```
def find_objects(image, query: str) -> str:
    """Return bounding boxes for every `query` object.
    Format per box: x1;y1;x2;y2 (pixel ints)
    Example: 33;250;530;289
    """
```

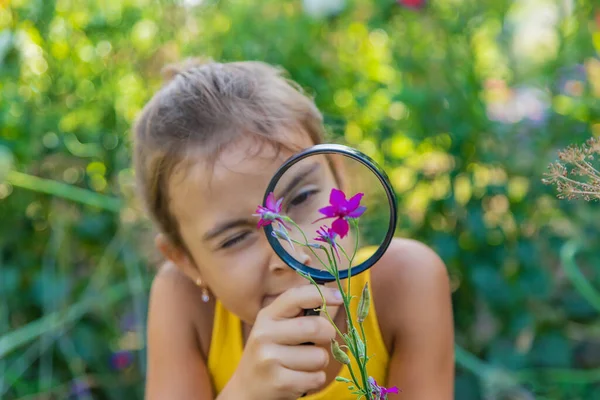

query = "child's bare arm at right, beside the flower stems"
375;240;454;400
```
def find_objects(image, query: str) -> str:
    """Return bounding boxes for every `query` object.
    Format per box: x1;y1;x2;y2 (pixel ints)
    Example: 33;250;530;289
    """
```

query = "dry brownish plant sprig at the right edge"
542;138;600;201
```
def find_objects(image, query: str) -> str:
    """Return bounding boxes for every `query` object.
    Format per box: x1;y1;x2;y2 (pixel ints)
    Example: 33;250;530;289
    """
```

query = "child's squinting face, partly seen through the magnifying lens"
169;134;346;324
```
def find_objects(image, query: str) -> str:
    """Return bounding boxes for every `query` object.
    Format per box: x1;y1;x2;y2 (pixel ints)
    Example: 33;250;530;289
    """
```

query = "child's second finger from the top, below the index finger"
270;316;336;346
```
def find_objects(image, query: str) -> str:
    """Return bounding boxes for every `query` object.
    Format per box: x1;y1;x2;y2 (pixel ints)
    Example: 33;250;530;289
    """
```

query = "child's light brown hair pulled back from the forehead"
133;59;324;249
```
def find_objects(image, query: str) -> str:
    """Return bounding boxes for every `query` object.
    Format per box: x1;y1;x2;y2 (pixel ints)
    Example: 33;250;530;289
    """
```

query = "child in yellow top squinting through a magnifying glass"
134;57;454;400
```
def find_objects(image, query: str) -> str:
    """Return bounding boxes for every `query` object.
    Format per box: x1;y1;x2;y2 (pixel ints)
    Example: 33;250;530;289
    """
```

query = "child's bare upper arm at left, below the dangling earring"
145;267;214;400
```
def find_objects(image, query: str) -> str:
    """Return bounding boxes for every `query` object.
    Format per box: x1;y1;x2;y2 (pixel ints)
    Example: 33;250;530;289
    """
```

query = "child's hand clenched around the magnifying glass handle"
223;285;342;400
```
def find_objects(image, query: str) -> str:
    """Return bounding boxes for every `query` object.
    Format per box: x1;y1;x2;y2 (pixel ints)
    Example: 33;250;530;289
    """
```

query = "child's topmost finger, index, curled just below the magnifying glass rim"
264;285;342;319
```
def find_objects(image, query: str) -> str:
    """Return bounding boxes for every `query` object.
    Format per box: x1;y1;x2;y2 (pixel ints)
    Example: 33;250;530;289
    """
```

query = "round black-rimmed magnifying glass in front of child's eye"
263;144;397;315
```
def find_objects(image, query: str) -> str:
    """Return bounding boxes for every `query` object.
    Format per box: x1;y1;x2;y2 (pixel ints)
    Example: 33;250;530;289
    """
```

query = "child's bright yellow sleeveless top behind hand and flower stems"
208;270;389;400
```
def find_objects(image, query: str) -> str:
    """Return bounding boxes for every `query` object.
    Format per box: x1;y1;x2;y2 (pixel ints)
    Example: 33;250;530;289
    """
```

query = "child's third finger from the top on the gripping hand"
270;346;329;372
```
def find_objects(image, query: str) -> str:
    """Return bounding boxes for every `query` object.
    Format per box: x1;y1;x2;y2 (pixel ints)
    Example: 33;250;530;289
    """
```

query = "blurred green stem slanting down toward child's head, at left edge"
6;171;122;213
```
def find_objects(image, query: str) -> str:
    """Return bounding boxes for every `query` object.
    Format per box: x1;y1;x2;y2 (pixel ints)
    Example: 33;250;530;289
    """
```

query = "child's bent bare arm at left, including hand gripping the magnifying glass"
146;262;341;400
